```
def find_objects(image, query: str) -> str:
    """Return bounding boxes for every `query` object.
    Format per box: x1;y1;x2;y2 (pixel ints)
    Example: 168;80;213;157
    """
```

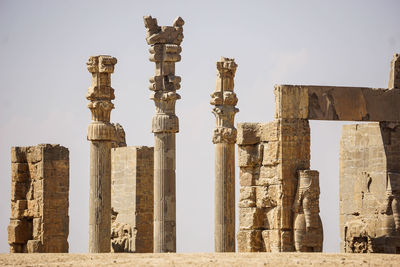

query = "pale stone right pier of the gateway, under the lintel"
340;122;400;253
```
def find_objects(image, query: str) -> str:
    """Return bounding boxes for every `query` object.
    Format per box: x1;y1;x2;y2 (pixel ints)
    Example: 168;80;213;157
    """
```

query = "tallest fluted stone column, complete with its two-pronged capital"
144;16;184;253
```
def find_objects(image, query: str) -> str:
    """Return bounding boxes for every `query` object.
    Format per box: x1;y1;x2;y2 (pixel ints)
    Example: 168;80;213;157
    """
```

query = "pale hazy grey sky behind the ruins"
0;0;400;253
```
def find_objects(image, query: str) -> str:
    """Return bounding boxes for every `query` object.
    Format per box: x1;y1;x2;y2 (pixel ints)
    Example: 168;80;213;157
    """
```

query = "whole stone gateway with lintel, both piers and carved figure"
237;54;400;253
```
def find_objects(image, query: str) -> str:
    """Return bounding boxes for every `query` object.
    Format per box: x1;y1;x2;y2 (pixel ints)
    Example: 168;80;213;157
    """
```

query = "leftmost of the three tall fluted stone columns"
86;55;117;253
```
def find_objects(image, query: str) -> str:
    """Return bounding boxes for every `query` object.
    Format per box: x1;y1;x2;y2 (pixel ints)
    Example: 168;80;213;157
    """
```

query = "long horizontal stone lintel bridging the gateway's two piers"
274;85;400;121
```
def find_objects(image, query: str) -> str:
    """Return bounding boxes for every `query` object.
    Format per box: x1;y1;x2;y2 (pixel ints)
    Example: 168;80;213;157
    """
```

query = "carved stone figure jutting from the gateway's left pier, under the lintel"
293;170;323;252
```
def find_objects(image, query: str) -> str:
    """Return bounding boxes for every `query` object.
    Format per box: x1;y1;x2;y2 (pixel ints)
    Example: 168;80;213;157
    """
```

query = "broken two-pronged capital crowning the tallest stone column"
143;16;185;45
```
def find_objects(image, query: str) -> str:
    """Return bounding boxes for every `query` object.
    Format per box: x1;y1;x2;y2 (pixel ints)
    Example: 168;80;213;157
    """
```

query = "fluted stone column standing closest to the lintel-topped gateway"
210;57;239;252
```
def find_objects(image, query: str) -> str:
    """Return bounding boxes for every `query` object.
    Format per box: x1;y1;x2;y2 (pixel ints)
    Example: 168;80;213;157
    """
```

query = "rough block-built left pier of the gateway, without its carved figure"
237;119;310;252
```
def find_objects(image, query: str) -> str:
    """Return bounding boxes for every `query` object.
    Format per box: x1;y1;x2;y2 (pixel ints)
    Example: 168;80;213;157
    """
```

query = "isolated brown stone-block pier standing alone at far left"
8;144;69;253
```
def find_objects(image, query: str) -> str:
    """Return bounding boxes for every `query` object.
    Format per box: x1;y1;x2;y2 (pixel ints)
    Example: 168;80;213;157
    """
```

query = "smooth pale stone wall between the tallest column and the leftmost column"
111;146;154;253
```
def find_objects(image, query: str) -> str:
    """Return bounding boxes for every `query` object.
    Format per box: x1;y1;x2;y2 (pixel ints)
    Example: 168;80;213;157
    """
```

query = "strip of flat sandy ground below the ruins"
0;253;400;266
